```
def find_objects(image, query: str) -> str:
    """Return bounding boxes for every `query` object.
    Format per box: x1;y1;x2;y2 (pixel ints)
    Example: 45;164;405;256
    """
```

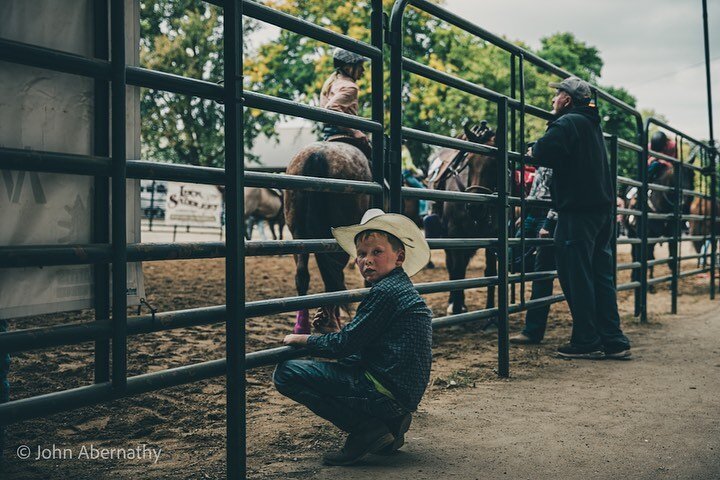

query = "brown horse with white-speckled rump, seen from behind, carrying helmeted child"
285;142;372;333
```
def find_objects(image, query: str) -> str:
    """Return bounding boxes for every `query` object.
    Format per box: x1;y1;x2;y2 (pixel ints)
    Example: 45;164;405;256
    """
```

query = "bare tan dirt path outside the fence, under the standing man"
314;300;720;480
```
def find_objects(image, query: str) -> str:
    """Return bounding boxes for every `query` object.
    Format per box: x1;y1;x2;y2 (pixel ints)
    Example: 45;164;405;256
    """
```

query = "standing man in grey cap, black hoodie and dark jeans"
528;77;630;359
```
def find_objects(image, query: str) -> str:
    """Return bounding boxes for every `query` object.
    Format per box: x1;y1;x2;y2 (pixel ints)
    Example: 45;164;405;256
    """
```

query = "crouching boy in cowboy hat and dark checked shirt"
273;209;432;465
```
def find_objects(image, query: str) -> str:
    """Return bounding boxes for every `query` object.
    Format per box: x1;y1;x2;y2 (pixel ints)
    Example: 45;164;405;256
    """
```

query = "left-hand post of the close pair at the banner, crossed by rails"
92;0;110;383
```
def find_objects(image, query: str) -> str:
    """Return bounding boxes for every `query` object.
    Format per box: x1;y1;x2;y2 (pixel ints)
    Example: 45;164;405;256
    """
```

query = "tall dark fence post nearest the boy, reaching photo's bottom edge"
223;0;247;480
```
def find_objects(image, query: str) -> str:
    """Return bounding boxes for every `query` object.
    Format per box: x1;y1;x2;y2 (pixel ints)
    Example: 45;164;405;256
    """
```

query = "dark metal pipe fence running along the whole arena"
0;0;716;479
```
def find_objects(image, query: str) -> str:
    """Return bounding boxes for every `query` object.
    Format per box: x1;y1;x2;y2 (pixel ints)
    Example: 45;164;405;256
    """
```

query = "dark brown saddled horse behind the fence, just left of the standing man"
434;124;498;314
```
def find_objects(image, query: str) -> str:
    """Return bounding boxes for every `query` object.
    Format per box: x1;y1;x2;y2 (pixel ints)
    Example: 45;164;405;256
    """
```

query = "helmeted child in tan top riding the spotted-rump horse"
320;48;370;158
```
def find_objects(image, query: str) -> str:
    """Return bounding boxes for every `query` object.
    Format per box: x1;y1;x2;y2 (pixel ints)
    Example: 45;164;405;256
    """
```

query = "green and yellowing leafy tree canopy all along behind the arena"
141;0;652;174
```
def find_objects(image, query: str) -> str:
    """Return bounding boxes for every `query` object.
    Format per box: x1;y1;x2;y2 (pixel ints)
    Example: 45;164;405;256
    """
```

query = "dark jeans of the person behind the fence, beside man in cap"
516;216;555;342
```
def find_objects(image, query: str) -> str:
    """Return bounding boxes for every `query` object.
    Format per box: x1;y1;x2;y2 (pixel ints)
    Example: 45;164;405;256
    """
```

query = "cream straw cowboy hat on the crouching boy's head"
332;208;430;277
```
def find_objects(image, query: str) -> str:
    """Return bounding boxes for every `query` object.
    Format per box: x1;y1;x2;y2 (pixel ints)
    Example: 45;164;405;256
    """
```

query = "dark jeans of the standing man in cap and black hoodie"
555;213;630;347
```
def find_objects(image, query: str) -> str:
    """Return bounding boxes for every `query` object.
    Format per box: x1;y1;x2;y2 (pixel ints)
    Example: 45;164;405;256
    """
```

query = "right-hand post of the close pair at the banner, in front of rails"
110;0;127;390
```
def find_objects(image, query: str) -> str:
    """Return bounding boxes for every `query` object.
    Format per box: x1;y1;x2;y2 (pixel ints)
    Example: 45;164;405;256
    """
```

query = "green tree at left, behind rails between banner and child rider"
140;0;256;167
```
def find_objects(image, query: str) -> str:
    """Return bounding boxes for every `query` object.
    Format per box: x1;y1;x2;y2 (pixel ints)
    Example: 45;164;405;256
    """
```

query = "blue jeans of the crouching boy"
273;360;407;433
